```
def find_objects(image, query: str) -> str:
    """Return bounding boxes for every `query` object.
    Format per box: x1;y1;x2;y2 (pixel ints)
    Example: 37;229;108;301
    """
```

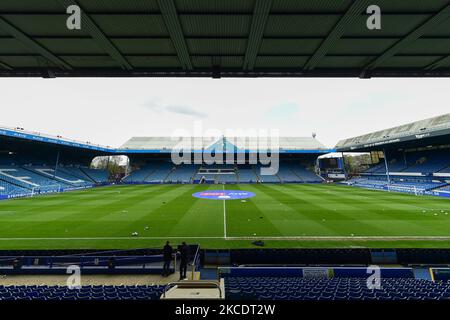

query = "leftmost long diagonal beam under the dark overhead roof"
0;17;72;70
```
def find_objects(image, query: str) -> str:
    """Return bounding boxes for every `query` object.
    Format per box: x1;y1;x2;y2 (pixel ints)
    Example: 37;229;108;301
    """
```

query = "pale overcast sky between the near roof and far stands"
0;78;450;147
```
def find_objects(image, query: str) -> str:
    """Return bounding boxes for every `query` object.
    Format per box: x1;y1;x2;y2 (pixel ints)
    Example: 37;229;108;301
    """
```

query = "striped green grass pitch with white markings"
0;184;450;249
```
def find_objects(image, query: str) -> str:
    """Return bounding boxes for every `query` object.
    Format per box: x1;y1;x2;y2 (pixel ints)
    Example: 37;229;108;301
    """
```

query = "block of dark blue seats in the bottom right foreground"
225;276;450;300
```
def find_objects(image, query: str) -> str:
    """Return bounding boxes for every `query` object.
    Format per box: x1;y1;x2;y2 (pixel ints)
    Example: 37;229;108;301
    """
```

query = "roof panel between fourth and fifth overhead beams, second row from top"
264;15;340;37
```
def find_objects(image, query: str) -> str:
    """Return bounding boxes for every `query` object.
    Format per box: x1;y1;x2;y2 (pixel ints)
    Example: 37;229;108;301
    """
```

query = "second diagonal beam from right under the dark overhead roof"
303;0;370;70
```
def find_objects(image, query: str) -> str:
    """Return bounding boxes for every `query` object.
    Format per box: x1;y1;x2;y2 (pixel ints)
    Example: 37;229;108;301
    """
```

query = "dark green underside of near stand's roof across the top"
0;0;450;77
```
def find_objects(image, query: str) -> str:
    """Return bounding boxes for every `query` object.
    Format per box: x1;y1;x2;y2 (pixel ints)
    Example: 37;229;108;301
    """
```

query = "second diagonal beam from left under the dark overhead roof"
54;0;133;70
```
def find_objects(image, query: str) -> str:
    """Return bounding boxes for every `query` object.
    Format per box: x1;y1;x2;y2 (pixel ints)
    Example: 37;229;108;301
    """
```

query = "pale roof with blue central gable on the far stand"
119;137;330;153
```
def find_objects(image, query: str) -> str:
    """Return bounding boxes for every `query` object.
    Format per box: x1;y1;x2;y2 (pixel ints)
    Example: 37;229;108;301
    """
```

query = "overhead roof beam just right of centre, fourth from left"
243;0;272;70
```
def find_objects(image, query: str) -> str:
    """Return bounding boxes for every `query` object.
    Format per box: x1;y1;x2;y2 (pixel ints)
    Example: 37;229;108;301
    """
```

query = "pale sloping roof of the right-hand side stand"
335;113;450;152
